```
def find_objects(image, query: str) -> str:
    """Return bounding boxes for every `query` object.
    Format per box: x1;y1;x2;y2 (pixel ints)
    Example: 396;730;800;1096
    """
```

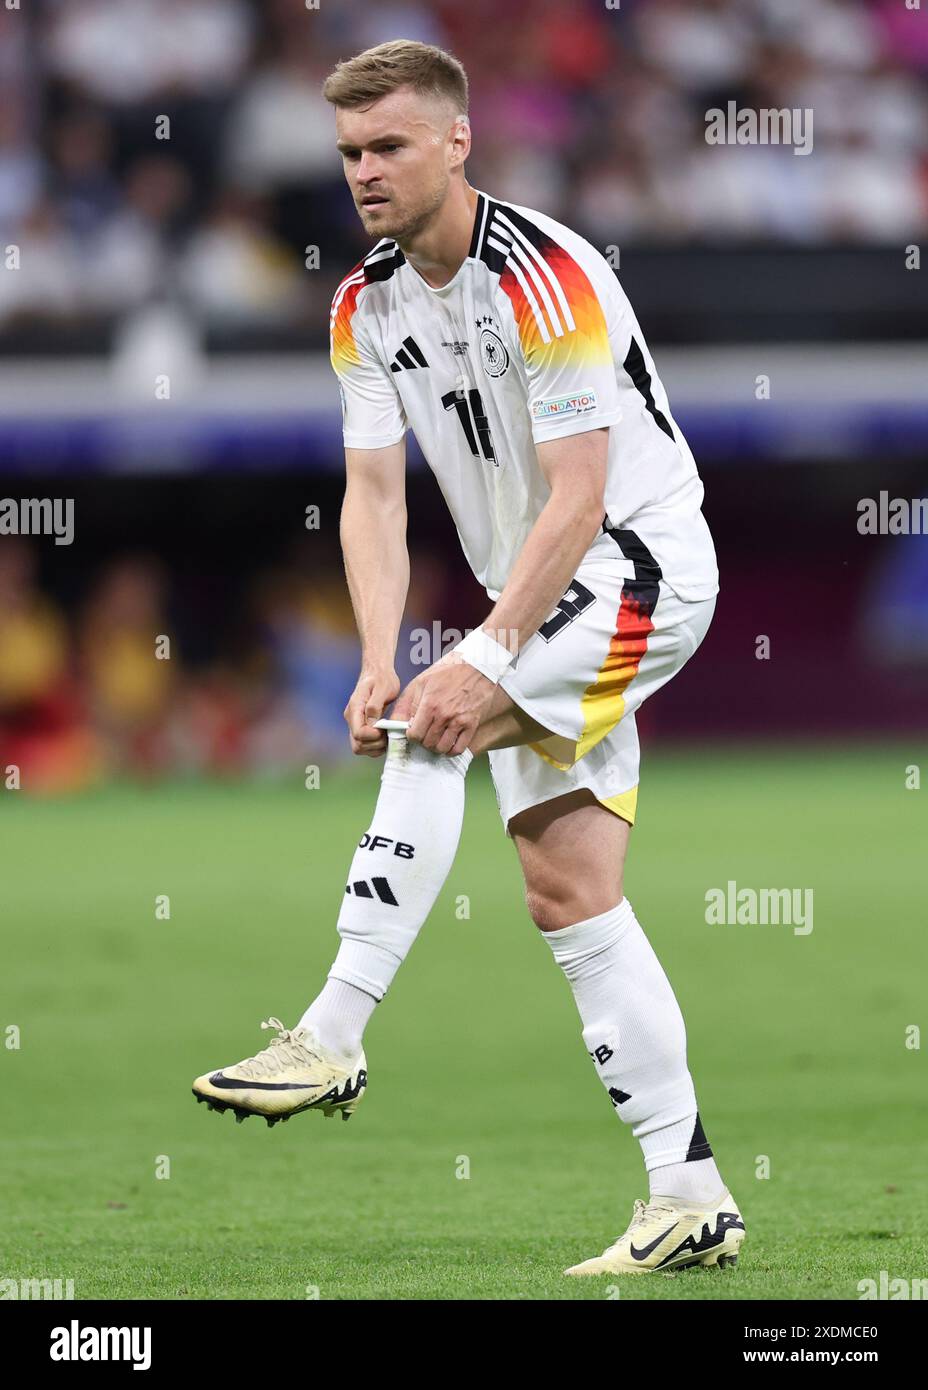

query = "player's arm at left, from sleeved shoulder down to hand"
329;264;410;758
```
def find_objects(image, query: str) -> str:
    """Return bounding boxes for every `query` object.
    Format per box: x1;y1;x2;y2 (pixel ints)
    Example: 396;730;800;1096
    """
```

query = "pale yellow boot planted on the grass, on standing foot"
564;1191;745;1275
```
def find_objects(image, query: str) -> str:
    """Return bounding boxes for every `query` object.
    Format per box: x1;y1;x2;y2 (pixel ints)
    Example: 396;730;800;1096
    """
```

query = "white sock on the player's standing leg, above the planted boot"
542;898;724;1201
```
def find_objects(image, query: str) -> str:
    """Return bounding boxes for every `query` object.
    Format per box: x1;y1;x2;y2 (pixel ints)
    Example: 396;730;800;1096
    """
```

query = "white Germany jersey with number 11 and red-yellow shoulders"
331;193;718;600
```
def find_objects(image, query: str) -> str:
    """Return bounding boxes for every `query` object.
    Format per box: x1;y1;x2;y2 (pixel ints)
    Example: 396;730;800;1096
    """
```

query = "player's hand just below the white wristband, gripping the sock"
390;652;496;756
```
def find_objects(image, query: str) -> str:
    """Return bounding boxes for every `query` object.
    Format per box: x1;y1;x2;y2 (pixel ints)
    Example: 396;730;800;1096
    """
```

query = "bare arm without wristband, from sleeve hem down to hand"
340;439;410;758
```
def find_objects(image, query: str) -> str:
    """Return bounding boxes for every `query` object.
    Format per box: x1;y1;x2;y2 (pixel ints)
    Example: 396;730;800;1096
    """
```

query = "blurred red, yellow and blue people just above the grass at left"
0;537;464;794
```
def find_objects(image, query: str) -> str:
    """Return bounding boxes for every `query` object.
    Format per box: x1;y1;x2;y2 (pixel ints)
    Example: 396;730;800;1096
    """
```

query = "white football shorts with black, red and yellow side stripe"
488;531;715;834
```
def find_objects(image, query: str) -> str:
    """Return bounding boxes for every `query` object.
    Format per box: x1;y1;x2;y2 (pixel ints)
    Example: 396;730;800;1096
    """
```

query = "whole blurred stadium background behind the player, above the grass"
0;0;928;791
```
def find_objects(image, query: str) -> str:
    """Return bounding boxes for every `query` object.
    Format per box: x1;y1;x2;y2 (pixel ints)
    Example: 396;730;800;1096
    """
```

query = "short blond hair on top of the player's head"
322;39;467;115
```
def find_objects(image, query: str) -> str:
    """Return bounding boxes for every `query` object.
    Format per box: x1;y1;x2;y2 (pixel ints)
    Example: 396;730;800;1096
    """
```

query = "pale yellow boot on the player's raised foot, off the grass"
193;1019;367;1125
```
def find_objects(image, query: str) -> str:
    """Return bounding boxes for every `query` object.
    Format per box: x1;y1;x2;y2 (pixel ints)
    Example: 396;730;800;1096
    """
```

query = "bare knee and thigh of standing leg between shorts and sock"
508;788;632;931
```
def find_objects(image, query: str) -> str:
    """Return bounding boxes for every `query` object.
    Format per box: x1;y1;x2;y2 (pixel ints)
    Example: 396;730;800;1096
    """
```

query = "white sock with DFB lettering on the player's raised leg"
300;738;474;1056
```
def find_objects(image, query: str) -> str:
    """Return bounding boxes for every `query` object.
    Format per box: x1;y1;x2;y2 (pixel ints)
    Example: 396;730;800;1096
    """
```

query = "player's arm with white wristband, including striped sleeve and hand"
393;229;622;753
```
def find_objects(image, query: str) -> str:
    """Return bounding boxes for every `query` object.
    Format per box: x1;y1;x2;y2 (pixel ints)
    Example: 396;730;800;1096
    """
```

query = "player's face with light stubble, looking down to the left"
335;88;461;245
